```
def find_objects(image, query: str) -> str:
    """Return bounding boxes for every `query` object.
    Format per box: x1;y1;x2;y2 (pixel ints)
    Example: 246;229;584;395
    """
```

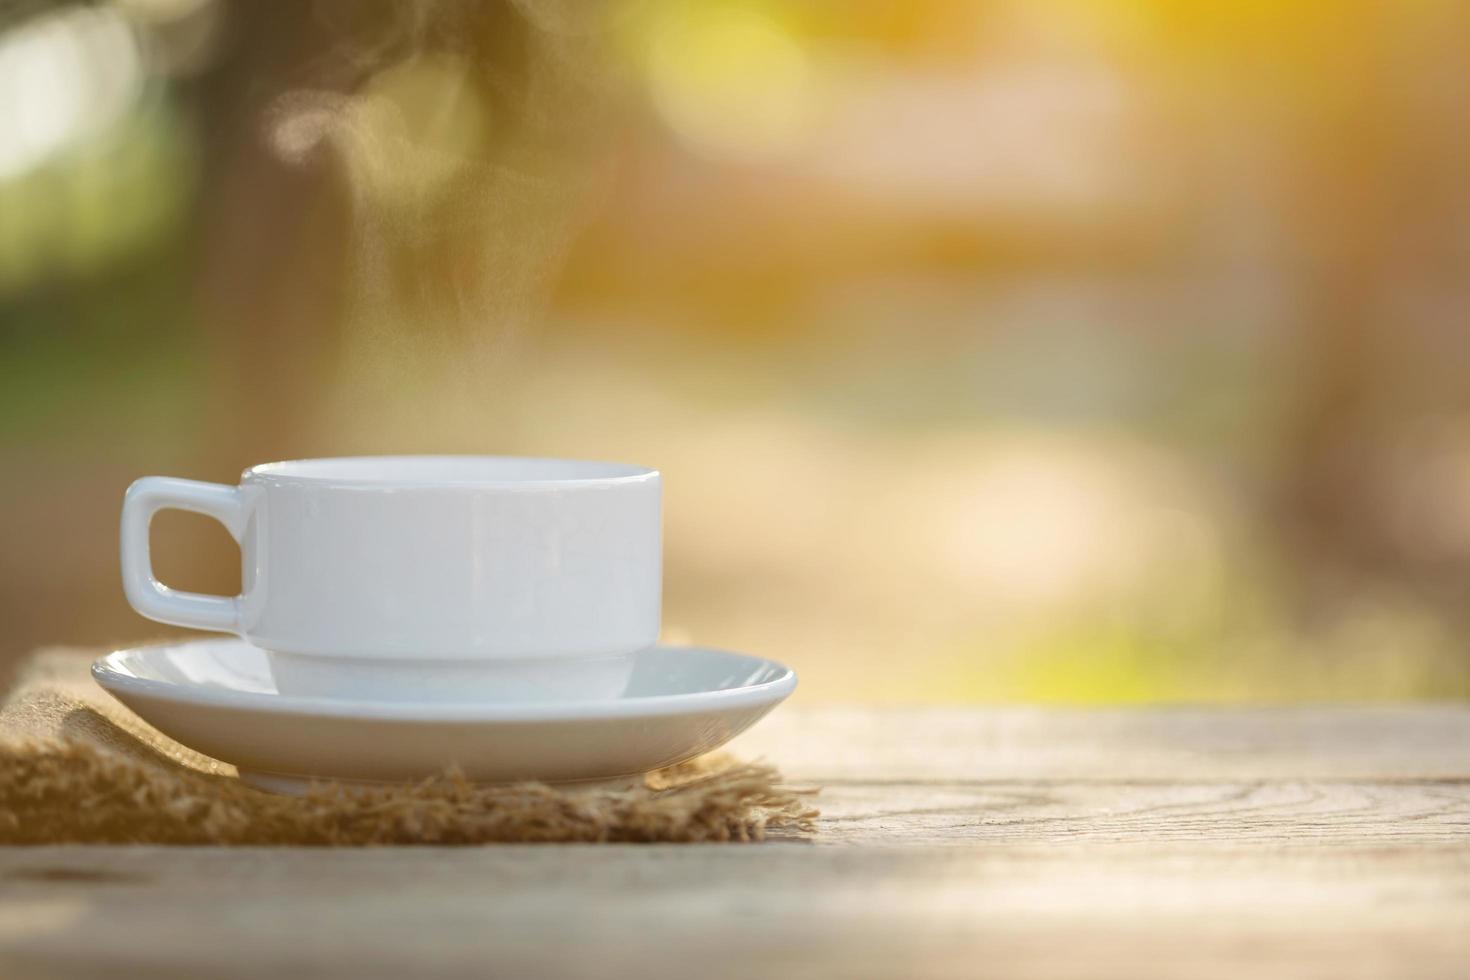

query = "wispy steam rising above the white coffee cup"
265;0;613;431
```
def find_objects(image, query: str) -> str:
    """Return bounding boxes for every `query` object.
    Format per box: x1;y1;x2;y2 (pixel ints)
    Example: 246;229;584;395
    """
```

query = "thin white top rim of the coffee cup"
241;454;659;489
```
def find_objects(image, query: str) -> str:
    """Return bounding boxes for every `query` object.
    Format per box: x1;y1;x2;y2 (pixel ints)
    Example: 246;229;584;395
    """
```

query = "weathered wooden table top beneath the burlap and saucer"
0;707;1470;980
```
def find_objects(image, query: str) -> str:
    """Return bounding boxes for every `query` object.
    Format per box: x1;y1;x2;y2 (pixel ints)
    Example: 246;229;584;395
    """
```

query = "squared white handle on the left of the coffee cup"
122;476;248;633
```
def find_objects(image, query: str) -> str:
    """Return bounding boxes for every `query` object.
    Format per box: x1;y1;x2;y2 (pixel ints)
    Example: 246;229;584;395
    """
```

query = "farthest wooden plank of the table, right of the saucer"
734;705;1470;782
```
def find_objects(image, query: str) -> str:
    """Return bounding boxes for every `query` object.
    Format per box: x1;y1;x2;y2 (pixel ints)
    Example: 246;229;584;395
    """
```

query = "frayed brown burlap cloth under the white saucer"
0;649;816;845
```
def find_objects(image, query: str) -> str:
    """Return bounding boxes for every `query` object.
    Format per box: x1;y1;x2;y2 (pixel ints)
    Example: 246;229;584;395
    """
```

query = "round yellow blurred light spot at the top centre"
647;4;813;159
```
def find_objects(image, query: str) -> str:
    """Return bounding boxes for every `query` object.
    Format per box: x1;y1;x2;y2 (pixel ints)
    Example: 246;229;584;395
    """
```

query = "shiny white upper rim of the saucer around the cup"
91;638;797;723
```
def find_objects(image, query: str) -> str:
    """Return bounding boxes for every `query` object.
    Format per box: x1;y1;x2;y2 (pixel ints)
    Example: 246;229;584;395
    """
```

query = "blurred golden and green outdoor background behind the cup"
0;0;1470;702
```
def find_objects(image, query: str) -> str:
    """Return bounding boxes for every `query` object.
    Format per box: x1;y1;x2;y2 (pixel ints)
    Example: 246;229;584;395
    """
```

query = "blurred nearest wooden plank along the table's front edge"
0;845;1470;980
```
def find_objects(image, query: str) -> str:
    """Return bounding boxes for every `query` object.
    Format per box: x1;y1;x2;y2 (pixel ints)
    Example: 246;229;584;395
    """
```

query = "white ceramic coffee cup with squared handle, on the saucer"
122;455;663;696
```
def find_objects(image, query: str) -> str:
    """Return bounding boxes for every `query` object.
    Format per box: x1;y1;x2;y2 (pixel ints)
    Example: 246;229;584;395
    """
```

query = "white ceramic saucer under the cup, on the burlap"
93;638;797;792
